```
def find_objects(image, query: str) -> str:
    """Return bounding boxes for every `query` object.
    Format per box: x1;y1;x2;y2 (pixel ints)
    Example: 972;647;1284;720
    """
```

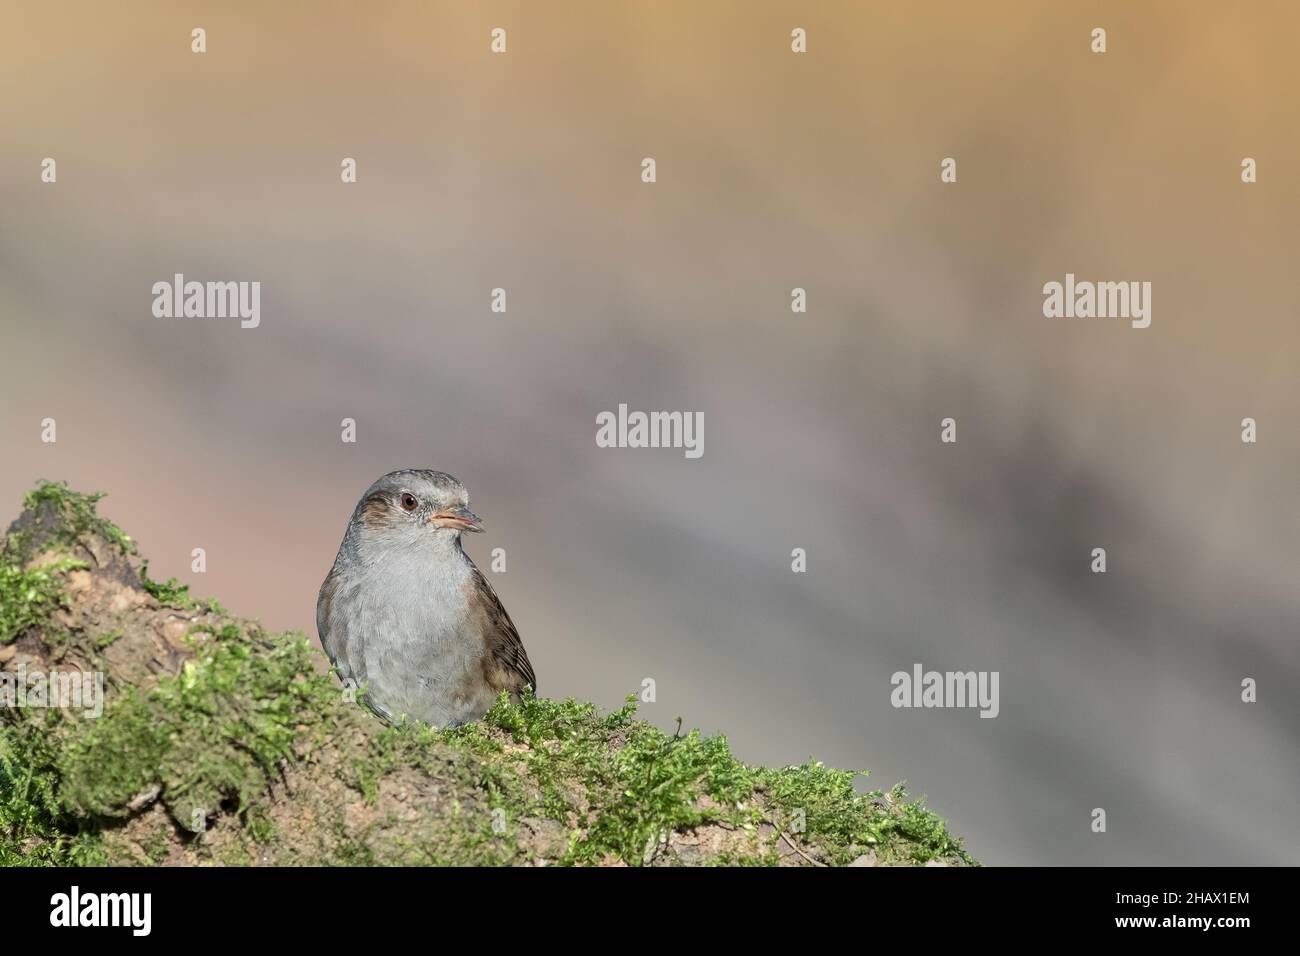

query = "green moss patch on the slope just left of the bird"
0;627;348;863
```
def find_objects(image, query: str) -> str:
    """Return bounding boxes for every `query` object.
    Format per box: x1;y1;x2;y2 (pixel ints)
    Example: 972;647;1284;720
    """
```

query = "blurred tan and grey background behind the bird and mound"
0;0;1300;865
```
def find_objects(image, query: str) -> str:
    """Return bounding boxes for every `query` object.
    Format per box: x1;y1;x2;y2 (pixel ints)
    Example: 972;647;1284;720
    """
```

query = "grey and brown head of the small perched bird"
351;468;482;550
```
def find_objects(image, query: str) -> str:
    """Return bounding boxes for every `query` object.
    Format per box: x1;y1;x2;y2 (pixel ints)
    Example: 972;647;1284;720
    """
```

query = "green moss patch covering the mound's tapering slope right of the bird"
428;696;974;865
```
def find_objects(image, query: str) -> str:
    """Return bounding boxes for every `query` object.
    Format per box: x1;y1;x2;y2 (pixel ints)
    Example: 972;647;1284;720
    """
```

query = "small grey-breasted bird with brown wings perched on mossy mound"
316;468;537;728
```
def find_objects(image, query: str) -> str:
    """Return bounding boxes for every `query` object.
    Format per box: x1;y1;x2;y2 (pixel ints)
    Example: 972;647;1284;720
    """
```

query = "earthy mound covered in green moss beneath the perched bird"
0;483;972;865
